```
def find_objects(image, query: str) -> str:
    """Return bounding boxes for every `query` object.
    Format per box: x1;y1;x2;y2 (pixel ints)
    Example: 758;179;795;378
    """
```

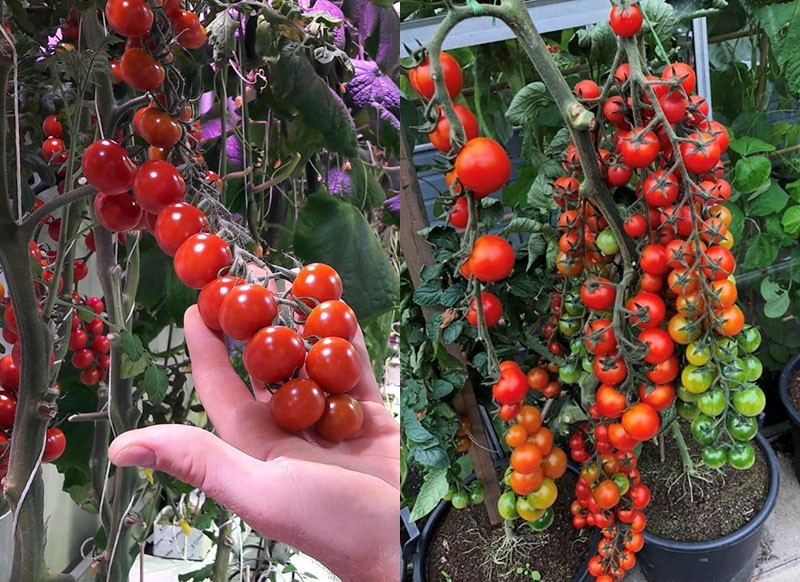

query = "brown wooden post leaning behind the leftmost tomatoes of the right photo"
400;132;503;526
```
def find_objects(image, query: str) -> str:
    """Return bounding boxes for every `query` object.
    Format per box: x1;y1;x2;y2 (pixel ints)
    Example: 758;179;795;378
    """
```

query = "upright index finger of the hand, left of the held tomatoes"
183;305;253;432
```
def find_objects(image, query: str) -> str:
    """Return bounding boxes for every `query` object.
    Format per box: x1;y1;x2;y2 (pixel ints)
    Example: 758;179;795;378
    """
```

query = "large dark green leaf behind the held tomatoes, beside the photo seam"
294;192;400;323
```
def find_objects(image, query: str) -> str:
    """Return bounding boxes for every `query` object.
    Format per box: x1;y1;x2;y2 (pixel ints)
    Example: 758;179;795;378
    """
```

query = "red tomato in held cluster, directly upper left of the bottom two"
242;326;306;384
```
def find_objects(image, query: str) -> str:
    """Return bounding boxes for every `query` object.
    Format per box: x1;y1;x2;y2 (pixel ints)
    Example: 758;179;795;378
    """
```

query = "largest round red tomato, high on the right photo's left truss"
455;137;511;199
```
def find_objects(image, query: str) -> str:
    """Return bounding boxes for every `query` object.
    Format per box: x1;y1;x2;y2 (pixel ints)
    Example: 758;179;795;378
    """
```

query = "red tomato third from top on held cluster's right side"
306;337;362;394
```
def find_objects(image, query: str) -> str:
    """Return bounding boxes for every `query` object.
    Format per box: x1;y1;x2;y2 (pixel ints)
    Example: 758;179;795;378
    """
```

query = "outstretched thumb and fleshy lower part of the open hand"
109;425;400;581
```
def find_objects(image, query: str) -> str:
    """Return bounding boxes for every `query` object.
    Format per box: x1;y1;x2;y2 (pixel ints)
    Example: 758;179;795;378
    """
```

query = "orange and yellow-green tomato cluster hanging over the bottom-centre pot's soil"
497;404;567;531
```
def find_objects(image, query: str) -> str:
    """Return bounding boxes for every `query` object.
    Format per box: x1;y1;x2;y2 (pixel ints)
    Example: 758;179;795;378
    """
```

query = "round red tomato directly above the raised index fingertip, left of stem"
174;233;233;289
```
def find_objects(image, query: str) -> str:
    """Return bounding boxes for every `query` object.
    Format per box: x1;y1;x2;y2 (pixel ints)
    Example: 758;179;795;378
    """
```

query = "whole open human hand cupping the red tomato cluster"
109;306;400;582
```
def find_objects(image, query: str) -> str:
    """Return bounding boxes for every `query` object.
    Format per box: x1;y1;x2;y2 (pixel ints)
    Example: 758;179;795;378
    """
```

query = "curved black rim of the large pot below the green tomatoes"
643;436;780;553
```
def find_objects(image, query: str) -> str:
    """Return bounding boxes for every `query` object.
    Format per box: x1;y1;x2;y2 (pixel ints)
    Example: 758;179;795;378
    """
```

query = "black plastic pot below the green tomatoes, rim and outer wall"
637;434;780;582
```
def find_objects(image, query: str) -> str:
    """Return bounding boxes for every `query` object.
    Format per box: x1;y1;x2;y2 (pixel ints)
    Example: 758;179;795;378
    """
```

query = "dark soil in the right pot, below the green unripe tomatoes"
639;430;770;542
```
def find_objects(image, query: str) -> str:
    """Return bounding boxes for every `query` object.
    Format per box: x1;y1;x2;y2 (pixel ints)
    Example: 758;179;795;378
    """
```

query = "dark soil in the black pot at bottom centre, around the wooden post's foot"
427;472;590;582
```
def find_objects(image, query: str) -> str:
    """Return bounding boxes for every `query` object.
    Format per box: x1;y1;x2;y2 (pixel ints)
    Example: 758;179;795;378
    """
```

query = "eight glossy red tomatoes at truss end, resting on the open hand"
197;263;364;441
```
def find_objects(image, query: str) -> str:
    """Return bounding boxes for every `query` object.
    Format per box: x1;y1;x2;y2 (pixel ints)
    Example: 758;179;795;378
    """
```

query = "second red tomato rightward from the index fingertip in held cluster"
219;286;278;341
